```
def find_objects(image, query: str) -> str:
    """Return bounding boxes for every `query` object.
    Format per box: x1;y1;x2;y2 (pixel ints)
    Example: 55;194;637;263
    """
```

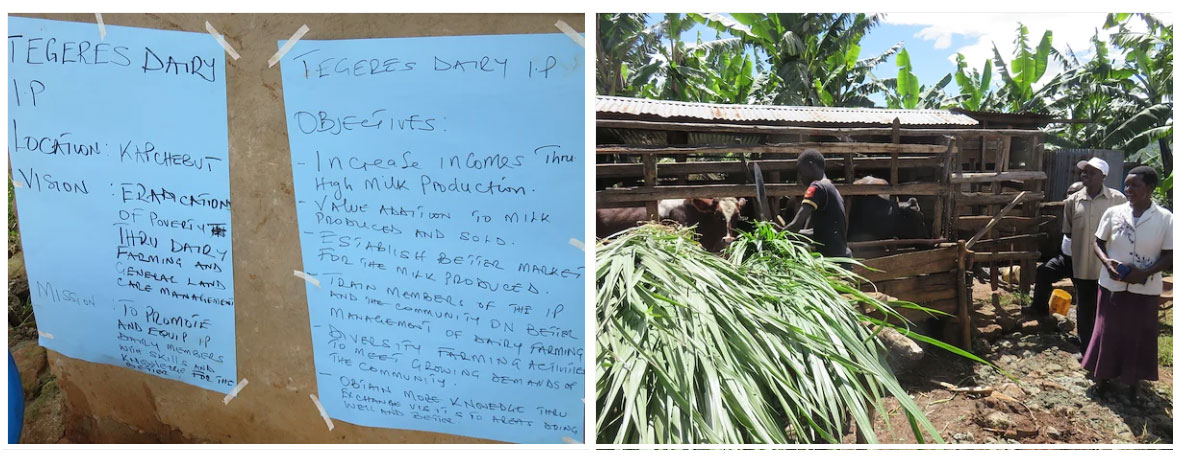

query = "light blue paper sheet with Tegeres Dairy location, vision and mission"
7;17;236;391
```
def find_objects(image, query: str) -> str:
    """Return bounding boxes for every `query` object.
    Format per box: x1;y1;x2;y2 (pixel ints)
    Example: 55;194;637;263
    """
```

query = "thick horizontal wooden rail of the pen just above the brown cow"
597;183;945;208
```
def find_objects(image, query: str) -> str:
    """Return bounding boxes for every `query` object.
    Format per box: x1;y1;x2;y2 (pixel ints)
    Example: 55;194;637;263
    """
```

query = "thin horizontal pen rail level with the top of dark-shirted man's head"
597;142;945;155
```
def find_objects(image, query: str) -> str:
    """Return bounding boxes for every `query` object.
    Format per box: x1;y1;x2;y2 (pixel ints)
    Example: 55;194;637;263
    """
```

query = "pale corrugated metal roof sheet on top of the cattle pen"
597;95;978;125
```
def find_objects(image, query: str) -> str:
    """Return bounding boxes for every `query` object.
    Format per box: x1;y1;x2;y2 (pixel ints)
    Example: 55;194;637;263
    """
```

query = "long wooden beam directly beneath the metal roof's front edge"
597;119;1043;136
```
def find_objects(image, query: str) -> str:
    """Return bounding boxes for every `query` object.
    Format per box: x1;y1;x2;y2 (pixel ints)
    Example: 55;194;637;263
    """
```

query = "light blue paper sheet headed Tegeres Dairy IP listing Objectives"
278;33;585;443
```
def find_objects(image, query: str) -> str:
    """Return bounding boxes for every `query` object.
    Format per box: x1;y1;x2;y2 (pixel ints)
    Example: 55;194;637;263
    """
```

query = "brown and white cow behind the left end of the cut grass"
597;197;746;252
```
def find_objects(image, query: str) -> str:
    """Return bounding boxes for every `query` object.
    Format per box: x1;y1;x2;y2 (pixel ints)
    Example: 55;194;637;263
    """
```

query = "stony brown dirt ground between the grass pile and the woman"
849;281;1173;444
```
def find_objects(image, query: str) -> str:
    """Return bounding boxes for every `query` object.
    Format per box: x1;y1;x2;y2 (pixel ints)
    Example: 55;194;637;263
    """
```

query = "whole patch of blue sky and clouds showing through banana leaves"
649;13;1172;105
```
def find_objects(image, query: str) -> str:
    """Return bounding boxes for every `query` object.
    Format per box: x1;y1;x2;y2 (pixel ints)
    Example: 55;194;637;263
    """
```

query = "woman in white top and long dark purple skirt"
1081;167;1173;400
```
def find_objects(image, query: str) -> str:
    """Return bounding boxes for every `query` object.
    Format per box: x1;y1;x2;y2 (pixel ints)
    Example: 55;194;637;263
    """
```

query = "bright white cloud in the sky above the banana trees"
883;13;1172;87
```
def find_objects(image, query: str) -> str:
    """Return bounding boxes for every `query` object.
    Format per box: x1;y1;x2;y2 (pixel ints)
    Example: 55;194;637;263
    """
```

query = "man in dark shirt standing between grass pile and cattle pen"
783;149;853;257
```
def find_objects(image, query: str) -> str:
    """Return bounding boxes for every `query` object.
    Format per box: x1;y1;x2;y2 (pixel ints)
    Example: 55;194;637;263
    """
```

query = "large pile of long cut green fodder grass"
597;224;976;444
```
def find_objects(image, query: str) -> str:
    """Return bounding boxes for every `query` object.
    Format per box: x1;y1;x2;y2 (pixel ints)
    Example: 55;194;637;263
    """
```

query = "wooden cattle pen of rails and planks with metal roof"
597;97;1047;346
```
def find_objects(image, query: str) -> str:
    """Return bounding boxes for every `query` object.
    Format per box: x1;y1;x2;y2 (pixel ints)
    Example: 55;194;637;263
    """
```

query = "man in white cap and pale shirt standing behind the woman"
1061;158;1126;354
